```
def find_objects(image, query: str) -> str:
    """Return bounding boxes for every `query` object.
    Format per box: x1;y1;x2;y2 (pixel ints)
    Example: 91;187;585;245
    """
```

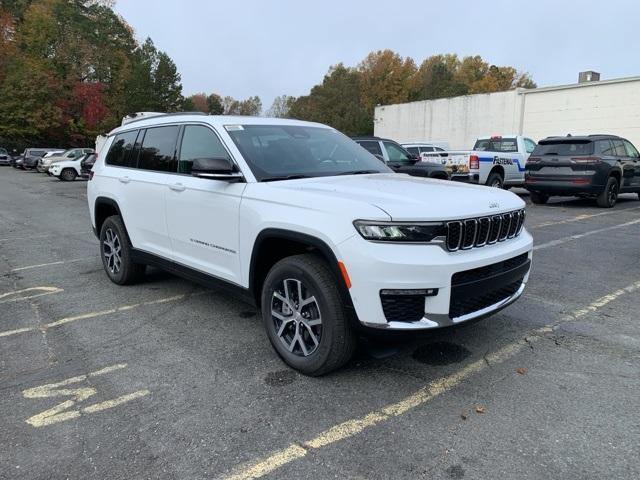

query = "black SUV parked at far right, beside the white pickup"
526;135;640;208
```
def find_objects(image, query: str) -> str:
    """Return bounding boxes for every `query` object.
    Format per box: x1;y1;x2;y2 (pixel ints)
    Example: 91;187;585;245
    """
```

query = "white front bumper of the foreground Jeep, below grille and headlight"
338;230;533;330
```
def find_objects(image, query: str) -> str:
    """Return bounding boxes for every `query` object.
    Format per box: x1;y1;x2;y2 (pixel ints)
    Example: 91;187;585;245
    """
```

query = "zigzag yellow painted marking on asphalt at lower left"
22;363;150;427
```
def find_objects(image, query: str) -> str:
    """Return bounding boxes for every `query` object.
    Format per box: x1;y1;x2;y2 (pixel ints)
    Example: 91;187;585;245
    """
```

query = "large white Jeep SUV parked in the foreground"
87;114;532;375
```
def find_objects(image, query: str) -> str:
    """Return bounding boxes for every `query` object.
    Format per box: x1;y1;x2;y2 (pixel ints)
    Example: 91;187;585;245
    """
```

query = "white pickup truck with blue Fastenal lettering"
430;135;536;188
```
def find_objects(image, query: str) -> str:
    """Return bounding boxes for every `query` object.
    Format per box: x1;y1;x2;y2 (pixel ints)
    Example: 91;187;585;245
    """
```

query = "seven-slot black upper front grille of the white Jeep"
446;209;525;252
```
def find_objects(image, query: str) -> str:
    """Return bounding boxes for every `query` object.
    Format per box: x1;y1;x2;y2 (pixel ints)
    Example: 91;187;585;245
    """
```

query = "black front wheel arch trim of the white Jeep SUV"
249;228;355;311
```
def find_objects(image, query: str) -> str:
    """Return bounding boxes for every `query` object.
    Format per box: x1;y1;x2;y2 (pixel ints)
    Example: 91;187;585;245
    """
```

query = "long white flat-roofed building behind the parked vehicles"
374;77;640;150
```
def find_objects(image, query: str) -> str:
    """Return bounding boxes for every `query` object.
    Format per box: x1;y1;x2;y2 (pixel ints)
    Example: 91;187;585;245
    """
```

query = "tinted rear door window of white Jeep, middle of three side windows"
138;126;180;173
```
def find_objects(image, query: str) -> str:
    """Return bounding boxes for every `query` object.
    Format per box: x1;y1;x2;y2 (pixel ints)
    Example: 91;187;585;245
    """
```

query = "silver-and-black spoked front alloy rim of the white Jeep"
271;278;322;357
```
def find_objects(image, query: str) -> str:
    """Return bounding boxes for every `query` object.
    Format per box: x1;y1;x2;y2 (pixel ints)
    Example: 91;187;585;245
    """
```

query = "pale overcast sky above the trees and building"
115;0;640;109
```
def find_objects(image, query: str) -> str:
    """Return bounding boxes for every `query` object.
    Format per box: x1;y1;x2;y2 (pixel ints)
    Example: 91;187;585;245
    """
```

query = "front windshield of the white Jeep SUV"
225;125;392;181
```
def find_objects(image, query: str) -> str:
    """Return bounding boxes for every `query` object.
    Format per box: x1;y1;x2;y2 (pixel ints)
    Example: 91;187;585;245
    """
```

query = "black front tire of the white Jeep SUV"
262;254;356;376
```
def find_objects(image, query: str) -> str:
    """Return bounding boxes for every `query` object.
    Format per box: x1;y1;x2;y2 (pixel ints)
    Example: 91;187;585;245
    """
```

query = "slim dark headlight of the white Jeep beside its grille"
353;220;447;243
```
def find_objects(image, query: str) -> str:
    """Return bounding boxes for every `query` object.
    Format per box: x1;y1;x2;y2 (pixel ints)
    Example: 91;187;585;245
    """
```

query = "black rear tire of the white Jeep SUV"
100;215;146;285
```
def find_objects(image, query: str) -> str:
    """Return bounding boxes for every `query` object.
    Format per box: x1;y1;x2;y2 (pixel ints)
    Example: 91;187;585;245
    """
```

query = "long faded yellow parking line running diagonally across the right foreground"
226;281;640;480
